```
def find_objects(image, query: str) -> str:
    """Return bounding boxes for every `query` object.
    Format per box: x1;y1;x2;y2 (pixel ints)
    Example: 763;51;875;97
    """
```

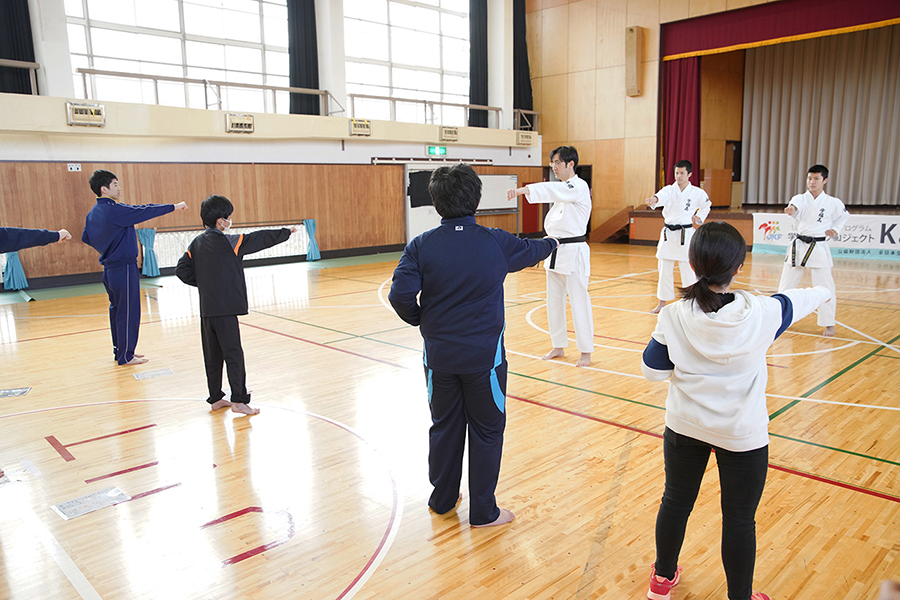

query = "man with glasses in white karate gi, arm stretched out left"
506;146;594;367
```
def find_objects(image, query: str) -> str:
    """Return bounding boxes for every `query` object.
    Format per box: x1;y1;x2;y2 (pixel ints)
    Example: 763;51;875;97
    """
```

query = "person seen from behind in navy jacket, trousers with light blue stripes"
389;164;559;527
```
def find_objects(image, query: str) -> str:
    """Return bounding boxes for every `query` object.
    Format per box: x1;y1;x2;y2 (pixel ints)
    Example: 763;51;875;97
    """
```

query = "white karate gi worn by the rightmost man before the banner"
778;190;850;327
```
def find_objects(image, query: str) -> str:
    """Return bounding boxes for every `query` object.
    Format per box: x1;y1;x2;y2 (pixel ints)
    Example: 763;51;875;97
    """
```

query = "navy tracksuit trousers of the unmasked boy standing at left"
103;262;141;365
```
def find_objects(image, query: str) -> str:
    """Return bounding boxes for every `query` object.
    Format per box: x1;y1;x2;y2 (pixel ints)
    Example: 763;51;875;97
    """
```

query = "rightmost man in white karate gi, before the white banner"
778;165;850;337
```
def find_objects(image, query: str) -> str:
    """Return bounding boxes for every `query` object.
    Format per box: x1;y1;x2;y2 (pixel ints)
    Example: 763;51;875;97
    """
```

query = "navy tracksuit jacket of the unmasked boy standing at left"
81;197;175;269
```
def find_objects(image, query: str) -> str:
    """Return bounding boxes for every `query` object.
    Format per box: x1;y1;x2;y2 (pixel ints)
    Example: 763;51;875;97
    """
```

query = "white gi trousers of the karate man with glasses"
547;269;594;354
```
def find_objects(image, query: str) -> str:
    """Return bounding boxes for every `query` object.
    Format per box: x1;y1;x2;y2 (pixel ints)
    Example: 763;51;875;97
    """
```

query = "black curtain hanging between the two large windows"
287;0;321;115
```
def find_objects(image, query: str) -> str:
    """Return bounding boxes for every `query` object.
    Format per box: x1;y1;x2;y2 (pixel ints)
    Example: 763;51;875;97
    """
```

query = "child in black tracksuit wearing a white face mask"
175;195;297;415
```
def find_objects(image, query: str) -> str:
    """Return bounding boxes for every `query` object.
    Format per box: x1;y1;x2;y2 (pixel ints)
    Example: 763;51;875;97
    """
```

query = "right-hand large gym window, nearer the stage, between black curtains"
344;0;469;126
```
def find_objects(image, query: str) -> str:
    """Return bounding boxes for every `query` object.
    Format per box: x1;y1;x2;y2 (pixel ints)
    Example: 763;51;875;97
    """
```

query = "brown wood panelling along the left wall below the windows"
0;162;406;277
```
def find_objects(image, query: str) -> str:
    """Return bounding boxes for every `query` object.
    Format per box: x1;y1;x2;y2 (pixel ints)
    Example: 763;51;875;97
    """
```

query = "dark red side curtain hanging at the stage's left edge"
663;56;700;186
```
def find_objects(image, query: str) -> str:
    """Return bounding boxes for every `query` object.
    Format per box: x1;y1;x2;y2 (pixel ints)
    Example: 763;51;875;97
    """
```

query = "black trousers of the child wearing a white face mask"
200;315;250;404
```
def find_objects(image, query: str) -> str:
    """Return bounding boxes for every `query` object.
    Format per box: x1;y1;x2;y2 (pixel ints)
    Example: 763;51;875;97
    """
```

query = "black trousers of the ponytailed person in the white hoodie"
656;427;769;600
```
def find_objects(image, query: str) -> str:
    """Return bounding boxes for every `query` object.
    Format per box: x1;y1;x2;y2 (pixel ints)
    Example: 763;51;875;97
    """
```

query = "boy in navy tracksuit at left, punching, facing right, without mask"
81;169;187;365
